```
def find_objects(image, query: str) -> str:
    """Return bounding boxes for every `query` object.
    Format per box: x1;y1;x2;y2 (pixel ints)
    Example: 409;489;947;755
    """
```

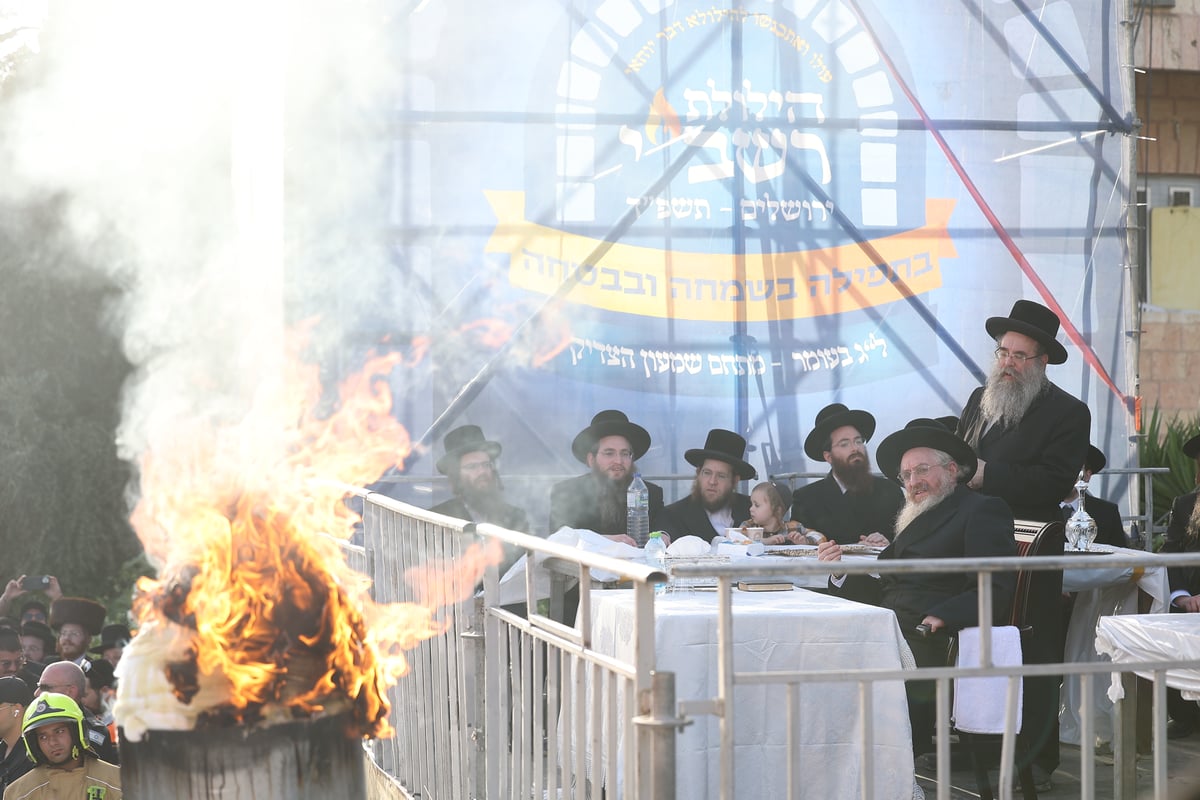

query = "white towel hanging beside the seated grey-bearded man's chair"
954;626;1025;733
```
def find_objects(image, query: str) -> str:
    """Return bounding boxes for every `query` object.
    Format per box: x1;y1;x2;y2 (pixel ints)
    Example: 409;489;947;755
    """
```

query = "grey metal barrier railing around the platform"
350;495;1200;800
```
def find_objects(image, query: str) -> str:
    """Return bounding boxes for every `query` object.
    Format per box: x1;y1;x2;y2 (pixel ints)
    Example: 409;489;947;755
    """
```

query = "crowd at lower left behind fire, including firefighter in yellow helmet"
0;575;132;800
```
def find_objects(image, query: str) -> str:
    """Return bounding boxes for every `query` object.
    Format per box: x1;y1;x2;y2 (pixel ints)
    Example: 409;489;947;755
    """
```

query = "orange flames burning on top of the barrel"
122;331;499;735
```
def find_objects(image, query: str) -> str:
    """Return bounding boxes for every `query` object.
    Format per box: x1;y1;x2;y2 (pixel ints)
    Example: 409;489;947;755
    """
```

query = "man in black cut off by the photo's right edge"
1156;434;1200;739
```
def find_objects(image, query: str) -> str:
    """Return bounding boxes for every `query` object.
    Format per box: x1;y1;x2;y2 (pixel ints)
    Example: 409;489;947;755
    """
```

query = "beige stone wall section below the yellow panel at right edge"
1139;306;1200;420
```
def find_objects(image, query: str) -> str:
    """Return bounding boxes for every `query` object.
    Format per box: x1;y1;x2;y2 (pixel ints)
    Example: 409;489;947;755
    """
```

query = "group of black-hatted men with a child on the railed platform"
420;300;1200;789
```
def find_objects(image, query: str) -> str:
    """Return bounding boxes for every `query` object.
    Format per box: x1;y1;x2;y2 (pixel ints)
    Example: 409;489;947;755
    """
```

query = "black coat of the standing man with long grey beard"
959;384;1092;522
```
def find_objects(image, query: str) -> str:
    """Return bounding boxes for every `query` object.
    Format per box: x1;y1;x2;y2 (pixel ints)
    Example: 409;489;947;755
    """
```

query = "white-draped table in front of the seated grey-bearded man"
592;590;913;800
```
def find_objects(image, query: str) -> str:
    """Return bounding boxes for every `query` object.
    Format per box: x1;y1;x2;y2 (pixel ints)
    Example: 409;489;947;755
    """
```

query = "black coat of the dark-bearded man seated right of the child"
792;473;904;545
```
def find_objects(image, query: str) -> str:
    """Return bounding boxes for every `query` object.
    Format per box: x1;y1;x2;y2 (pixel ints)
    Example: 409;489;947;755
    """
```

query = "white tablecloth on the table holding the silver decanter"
1058;545;1170;745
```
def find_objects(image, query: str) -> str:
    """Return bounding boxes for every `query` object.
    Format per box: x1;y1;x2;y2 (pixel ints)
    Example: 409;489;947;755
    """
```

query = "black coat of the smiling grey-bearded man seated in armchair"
833;485;1016;633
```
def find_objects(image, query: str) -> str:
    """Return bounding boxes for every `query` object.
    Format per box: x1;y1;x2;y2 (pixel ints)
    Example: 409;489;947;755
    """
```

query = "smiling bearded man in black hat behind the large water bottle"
550;409;662;545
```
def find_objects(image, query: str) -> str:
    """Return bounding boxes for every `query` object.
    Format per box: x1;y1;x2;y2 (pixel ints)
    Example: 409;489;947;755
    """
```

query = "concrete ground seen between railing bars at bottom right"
917;734;1200;800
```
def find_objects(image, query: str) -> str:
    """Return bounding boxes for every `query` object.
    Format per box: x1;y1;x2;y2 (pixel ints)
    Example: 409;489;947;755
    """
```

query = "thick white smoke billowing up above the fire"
0;0;408;482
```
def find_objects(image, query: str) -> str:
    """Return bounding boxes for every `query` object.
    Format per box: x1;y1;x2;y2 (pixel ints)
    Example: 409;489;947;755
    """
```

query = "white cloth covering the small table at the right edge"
1096;614;1200;700
